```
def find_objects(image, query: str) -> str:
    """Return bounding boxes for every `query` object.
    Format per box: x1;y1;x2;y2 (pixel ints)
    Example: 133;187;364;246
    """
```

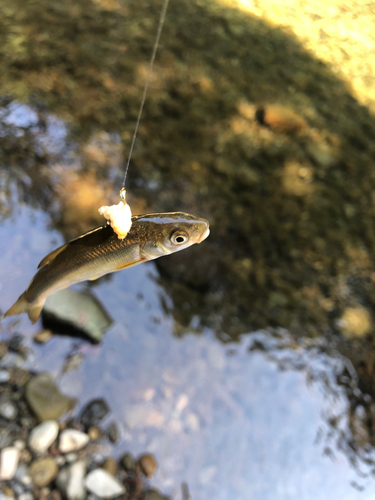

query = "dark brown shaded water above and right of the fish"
0;0;375;492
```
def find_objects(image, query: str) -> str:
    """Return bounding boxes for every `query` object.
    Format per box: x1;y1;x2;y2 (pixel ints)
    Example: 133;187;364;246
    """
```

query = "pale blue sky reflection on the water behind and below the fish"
0;206;375;500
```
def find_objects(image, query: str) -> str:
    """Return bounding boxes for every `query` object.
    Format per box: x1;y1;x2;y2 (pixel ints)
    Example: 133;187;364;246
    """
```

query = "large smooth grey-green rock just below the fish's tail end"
42;289;112;342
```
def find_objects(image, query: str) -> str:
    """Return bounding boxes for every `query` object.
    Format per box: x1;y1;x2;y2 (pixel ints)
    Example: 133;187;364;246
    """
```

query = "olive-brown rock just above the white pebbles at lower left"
25;373;73;422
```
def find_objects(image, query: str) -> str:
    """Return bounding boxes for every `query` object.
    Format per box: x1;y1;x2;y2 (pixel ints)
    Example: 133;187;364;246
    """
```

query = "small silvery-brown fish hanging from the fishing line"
5;212;210;323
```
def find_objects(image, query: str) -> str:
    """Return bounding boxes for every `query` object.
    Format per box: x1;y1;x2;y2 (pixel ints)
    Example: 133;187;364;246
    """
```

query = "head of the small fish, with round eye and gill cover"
139;212;210;260
